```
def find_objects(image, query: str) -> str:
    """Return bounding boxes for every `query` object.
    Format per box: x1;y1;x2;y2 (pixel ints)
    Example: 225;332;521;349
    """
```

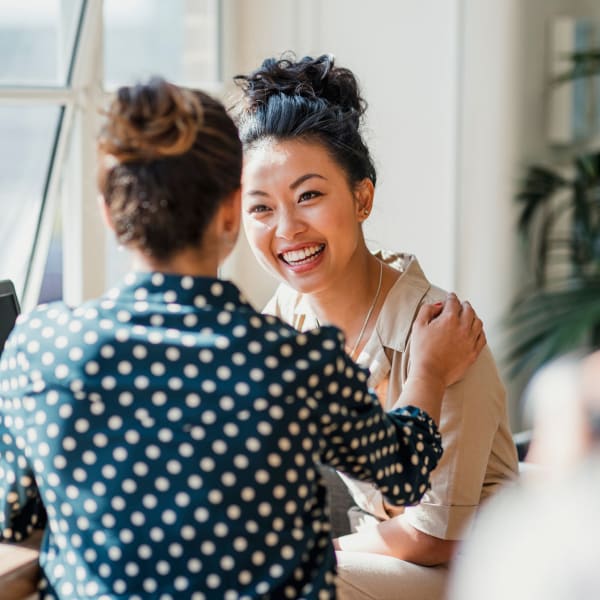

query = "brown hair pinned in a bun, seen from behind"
98;78;242;260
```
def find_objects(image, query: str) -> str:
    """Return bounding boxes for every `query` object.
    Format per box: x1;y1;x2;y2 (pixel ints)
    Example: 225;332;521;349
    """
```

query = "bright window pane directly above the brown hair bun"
104;0;219;88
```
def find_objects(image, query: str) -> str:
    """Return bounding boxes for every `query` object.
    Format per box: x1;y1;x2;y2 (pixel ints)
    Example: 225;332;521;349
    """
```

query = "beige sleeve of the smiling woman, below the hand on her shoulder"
405;348;517;540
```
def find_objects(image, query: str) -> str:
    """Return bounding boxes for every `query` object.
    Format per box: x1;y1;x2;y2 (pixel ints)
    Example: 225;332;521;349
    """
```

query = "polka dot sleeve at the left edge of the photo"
0;326;46;542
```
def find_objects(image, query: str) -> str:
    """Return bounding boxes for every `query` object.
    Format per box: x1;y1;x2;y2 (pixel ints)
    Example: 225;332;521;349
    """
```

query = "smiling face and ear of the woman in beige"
243;140;377;296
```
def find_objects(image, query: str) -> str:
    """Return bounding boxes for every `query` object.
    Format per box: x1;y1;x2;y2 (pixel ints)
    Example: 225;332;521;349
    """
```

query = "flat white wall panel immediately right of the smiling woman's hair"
319;0;458;288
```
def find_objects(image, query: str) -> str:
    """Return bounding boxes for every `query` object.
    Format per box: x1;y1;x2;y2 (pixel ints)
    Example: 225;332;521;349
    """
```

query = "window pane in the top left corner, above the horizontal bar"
0;0;83;87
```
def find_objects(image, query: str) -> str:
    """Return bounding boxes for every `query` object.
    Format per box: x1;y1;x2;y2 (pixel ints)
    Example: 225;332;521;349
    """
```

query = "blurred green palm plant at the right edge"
508;49;600;373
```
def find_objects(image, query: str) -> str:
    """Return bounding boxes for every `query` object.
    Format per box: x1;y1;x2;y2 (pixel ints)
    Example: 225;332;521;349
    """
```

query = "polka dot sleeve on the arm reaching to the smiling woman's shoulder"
309;327;442;505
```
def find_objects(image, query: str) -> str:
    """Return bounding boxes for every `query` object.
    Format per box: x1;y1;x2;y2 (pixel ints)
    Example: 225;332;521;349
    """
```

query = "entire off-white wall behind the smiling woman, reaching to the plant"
221;0;600;427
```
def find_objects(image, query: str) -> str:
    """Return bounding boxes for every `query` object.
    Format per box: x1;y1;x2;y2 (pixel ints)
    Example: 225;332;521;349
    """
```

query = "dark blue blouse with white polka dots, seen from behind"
0;273;441;600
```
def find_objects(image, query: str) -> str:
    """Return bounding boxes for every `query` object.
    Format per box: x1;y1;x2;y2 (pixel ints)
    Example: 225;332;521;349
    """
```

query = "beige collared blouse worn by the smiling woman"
264;252;517;540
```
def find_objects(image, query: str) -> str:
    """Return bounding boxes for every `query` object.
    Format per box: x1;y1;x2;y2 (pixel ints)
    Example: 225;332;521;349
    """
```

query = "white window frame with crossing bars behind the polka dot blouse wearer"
0;0;224;311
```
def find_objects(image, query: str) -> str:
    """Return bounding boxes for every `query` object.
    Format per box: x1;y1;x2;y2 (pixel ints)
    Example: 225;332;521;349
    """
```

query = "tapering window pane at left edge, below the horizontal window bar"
0;105;62;297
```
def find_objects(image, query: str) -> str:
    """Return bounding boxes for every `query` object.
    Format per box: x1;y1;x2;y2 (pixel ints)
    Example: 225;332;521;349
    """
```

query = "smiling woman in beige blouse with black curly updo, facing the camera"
237;56;517;600
